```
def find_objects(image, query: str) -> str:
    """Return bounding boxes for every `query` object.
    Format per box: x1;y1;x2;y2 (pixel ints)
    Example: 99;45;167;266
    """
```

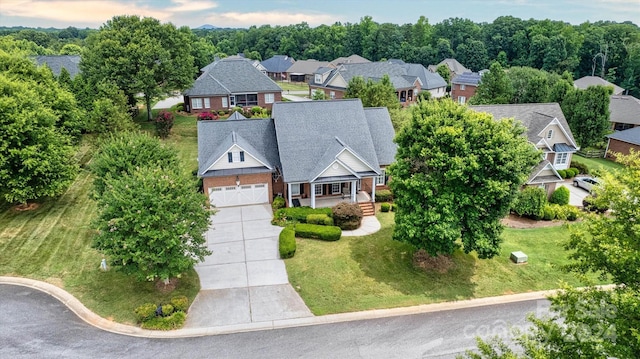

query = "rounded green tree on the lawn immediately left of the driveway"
93;165;211;284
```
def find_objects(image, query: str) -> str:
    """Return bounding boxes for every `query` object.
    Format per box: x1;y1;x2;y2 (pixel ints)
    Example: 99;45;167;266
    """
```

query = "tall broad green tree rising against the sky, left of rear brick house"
80;16;196;120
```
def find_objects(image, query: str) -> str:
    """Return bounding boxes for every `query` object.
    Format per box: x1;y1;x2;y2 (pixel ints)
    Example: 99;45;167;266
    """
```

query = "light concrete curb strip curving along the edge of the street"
0;276;614;339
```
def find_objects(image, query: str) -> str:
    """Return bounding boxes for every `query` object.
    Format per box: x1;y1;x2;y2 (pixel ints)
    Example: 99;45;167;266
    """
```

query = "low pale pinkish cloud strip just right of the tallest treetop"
212;10;340;27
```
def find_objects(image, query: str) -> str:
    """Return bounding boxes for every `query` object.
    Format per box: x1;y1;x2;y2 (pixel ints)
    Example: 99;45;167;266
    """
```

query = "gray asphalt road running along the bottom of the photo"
0;285;548;359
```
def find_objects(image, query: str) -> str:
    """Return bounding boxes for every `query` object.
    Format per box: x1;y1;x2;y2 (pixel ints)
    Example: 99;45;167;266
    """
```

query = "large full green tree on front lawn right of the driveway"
389;101;539;258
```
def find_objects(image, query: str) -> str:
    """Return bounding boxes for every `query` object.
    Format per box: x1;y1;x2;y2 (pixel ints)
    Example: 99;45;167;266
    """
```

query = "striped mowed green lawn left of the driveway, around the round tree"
0;117;200;323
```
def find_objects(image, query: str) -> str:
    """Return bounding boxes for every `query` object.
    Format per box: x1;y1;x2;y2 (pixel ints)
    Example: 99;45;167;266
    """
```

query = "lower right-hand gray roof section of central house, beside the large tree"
364;107;398;166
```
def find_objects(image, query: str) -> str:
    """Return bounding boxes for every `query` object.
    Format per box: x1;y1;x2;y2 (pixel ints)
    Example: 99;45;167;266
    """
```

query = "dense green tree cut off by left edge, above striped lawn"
0;73;78;204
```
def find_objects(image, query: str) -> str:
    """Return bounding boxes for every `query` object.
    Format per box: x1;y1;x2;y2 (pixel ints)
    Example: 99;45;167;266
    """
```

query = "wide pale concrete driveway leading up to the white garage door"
185;204;312;328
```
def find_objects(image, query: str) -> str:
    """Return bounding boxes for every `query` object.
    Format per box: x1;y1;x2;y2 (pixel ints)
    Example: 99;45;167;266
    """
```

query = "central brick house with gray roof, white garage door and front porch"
198;99;396;208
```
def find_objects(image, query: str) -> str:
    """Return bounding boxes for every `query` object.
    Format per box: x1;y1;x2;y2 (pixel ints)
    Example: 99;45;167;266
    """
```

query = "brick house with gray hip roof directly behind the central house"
183;57;282;113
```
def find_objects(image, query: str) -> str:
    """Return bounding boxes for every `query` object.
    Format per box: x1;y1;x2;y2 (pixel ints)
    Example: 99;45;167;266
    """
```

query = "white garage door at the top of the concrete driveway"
209;183;269;207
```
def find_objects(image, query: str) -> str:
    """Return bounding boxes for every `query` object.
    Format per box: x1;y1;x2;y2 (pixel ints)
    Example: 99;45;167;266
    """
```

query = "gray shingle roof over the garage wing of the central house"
198;119;280;177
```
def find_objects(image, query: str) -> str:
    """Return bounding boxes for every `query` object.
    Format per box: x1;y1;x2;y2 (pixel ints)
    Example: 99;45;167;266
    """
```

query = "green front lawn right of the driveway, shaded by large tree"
285;213;596;315
